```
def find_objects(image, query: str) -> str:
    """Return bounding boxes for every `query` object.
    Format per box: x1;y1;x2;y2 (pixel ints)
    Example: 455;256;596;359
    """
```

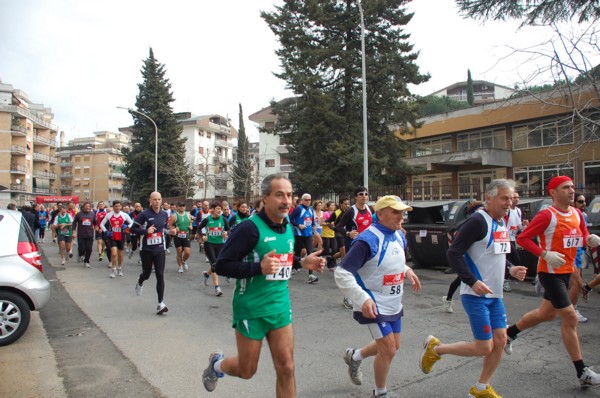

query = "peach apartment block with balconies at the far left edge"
0;81;58;208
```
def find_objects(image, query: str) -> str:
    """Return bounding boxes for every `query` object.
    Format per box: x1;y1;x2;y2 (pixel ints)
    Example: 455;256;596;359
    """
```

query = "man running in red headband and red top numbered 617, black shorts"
506;176;600;387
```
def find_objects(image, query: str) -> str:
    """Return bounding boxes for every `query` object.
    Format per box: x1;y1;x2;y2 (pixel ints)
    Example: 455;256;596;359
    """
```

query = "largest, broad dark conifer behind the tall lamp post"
261;0;429;191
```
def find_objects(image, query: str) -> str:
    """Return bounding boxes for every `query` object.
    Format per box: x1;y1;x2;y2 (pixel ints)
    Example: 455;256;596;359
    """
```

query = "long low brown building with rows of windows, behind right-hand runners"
402;87;600;200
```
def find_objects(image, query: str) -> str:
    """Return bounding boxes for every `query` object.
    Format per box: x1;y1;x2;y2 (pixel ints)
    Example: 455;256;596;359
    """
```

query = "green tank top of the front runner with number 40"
233;215;294;322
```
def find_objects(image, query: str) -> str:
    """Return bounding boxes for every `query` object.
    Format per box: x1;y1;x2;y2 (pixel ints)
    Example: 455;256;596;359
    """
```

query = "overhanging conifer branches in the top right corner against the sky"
456;0;600;25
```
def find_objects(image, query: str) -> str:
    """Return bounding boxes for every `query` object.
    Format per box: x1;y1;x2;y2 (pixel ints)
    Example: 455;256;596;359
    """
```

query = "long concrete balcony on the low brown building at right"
405;148;512;171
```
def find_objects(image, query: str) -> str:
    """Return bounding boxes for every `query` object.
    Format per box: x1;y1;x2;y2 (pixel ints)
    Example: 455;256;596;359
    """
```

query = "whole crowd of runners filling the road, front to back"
8;174;600;398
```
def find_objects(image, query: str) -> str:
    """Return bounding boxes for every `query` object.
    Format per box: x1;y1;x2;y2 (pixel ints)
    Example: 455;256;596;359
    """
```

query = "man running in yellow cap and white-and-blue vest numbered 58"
335;195;421;398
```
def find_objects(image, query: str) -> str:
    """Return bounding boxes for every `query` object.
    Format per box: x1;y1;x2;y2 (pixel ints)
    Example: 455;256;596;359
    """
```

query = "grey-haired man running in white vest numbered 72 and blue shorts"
419;179;527;398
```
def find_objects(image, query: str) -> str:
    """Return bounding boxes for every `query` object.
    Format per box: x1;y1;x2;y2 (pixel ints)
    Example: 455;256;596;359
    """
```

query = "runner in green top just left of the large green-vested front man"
198;202;229;297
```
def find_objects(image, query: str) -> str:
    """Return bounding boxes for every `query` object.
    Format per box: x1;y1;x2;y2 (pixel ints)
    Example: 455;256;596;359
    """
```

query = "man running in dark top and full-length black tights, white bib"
131;192;170;315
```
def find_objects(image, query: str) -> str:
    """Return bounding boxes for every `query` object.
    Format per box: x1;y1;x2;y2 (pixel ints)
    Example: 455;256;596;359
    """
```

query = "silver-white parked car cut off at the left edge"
0;209;50;346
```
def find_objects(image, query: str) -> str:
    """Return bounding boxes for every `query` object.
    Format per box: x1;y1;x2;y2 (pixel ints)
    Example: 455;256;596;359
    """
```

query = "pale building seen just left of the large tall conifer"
248;97;294;179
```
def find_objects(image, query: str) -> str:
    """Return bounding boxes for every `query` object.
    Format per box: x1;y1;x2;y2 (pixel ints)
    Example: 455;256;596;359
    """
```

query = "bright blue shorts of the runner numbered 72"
460;294;507;340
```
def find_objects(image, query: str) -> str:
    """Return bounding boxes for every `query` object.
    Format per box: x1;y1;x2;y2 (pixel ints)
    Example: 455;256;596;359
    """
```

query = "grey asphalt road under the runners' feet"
5;239;600;398
